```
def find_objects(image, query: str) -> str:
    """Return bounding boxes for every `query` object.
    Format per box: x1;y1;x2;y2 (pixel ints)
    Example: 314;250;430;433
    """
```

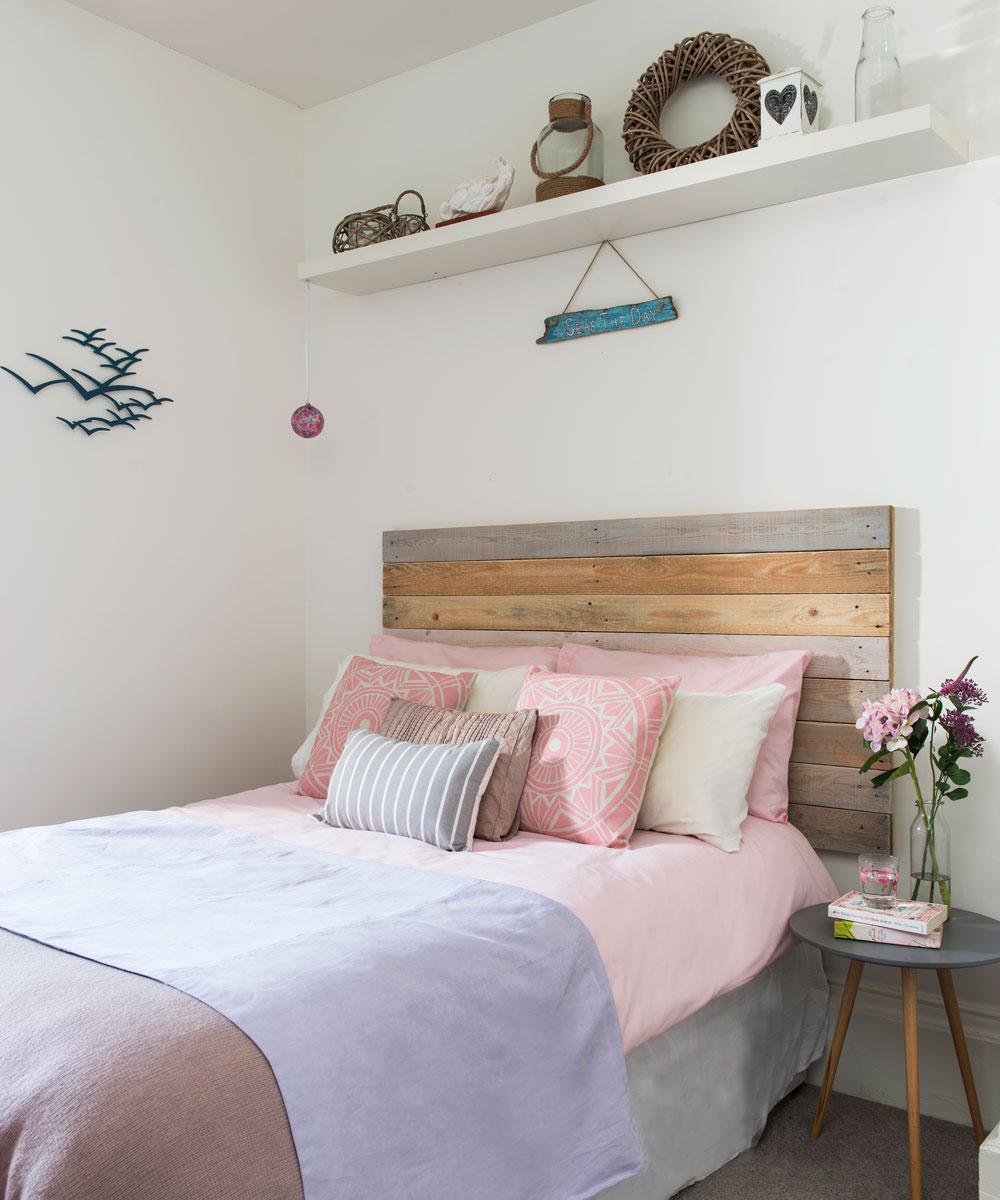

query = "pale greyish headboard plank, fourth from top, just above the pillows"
383;626;888;676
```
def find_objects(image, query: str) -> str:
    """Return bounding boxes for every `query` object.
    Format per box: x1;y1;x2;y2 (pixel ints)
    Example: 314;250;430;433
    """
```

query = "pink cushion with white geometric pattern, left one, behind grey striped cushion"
299;654;475;800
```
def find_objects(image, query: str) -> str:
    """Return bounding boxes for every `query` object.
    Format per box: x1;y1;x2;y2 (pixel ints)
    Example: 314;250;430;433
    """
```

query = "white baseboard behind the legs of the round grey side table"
809;959;1000;1128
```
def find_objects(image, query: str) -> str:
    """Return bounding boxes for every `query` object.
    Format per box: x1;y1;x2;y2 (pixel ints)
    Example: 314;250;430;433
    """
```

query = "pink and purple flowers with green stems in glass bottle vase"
857;658;987;907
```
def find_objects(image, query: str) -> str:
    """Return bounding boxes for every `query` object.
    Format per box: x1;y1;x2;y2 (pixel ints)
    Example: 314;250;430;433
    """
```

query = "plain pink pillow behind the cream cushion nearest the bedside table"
558;644;813;821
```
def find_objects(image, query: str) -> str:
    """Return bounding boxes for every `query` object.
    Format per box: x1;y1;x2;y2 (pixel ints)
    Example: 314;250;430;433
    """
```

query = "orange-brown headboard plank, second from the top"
383;550;891;596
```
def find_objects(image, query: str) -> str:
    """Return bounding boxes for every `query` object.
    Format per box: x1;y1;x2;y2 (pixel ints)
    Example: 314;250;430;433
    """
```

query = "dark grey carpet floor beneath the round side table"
678;1085;980;1200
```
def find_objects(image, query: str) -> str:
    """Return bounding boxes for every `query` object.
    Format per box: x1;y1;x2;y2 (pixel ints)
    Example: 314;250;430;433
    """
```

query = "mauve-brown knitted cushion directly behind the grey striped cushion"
378;700;538;841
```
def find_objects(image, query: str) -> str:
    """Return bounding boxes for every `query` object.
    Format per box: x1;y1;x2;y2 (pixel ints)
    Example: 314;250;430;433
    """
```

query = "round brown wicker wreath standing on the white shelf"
622;34;771;175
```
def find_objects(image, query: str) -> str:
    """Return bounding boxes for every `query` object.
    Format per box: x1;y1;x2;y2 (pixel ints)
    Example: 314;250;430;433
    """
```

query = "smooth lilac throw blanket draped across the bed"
0;812;641;1200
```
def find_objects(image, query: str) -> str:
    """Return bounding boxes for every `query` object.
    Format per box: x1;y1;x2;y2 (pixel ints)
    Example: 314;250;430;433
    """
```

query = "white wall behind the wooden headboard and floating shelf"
300;0;1000;1122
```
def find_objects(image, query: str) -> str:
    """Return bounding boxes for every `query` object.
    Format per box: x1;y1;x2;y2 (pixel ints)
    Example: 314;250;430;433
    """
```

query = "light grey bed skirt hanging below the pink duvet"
598;944;828;1200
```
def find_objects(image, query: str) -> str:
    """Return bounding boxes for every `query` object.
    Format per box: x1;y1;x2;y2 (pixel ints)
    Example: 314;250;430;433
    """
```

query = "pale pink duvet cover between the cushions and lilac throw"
178;784;837;1051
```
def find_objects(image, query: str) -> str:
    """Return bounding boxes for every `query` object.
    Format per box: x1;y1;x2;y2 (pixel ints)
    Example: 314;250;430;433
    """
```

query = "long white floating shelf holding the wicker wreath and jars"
299;104;969;295
